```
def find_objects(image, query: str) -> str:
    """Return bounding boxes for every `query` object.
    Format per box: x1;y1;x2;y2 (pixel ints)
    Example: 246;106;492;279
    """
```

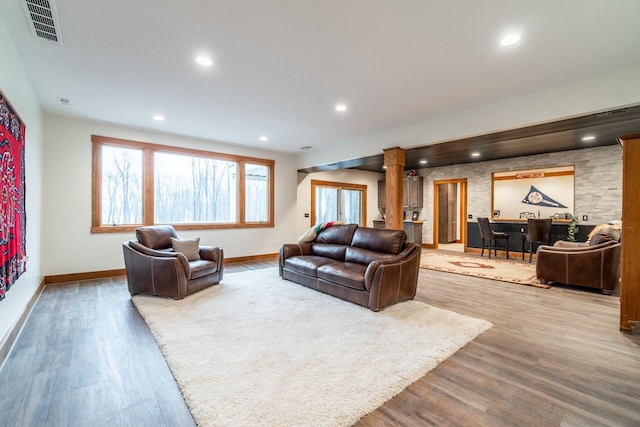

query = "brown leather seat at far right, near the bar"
536;229;622;295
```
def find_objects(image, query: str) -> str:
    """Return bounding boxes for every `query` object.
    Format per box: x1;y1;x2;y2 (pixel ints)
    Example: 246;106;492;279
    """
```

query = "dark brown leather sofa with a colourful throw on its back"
279;224;421;311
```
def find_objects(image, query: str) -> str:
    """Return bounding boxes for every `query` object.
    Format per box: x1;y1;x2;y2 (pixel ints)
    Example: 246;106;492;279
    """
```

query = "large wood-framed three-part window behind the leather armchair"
92;135;275;233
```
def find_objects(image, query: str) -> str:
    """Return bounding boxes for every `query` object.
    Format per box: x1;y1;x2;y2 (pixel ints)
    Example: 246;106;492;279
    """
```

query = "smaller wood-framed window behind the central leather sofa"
311;180;367;226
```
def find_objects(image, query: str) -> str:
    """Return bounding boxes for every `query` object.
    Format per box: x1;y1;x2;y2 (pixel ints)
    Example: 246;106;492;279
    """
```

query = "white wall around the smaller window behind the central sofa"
296;169;384;236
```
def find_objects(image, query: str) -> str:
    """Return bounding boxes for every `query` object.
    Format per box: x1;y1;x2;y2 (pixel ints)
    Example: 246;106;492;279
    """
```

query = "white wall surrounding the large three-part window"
43;114;297;276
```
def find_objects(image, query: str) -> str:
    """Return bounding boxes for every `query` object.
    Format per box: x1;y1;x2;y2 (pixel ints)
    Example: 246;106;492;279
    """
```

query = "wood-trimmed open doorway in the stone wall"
433;178;467;251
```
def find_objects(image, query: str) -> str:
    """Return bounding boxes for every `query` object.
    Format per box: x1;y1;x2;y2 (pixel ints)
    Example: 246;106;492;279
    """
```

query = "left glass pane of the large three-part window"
101;145;142;225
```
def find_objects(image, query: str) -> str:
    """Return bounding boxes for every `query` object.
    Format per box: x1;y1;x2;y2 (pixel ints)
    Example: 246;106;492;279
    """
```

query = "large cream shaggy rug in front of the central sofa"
133;268;491;426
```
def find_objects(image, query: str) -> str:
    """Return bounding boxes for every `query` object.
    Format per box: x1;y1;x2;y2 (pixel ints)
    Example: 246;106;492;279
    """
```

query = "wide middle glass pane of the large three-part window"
154;152;237;224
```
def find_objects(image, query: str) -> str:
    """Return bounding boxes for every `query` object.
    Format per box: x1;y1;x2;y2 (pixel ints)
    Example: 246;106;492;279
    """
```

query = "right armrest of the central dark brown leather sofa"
364;243;422;311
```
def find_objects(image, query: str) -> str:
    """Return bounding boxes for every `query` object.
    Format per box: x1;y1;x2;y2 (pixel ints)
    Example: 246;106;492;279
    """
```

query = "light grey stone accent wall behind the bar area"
417;145;624;244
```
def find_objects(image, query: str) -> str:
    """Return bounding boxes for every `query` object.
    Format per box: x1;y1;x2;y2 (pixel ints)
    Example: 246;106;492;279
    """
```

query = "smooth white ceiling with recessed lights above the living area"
0;0;640;153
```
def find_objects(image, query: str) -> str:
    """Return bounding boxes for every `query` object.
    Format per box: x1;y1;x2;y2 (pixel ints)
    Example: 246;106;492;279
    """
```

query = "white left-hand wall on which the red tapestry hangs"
0;16;42;348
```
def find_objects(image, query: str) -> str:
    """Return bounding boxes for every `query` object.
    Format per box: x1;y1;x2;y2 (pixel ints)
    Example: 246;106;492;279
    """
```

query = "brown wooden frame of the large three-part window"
91;135;275;233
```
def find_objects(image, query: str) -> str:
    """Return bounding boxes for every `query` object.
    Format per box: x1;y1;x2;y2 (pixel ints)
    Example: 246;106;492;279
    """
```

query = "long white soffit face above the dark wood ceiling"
297;64;640;169
